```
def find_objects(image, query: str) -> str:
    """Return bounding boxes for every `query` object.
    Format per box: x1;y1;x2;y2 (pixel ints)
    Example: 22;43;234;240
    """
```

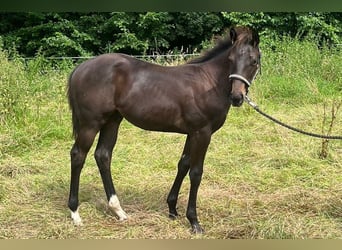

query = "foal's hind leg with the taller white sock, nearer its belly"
95;113;127;220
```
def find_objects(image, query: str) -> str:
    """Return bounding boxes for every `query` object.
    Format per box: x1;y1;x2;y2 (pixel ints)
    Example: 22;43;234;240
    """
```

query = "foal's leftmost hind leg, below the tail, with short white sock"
68;128;97;225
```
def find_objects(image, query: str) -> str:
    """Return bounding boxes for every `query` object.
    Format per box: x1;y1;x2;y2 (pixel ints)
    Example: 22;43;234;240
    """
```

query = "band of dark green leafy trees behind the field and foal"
0;12;342;57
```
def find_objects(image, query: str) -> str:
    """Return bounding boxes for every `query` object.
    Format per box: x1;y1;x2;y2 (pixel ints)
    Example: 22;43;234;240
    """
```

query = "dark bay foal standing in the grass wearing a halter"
68;27;260;233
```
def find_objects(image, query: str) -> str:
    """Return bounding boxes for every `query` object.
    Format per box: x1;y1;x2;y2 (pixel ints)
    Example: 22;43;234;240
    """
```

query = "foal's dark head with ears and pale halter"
228;28;260;107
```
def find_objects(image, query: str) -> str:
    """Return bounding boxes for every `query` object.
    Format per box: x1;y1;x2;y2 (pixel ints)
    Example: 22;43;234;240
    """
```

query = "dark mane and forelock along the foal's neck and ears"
187;27;259;64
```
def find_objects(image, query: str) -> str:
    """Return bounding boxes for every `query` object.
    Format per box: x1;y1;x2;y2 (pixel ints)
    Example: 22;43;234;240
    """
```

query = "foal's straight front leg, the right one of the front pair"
186;128;211;233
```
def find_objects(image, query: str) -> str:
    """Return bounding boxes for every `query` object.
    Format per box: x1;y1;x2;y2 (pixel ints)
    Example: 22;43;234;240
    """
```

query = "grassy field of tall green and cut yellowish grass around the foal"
0;39;342;239
